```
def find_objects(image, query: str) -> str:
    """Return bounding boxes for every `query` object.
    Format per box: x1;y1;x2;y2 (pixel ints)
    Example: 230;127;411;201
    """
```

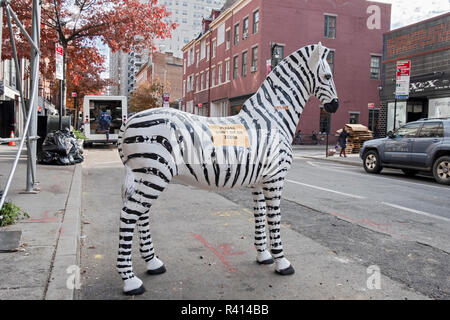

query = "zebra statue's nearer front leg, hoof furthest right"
263;181;295;275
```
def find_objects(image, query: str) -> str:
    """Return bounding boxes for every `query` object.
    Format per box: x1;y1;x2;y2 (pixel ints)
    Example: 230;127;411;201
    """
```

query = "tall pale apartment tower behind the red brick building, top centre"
155;0;225;58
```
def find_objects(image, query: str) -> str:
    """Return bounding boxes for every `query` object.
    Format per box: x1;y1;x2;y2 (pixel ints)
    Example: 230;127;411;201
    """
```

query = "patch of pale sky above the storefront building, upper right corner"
375;0;450;30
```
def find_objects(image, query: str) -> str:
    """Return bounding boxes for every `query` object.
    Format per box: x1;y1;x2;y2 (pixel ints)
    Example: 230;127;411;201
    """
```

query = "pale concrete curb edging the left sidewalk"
44;163;82;300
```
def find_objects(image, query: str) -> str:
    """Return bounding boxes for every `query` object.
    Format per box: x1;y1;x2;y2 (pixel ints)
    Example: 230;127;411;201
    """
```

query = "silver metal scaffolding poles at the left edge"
0;0;41;209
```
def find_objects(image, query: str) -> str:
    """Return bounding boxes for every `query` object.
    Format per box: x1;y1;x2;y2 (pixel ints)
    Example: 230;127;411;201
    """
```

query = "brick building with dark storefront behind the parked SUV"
380;13;450;135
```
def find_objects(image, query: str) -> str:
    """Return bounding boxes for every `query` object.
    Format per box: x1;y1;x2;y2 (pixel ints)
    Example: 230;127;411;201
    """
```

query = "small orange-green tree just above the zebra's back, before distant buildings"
129;78;170;112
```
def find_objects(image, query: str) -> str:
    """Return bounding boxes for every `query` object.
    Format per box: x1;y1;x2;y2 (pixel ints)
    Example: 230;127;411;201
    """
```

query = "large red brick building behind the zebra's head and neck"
183;0;391;140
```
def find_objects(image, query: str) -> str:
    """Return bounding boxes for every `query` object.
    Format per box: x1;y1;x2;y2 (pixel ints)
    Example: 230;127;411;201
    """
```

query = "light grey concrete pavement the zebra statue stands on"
79;149;427;300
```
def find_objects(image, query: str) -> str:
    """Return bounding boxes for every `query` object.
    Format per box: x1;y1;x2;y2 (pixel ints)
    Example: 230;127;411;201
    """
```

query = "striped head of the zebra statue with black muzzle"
308;42;339;113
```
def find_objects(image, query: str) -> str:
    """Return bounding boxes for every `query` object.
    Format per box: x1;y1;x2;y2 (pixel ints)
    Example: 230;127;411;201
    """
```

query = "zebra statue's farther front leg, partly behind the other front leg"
252;186;274;264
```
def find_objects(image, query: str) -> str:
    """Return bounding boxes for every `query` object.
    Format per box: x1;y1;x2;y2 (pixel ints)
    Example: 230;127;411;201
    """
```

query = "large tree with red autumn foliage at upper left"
2;0;176;106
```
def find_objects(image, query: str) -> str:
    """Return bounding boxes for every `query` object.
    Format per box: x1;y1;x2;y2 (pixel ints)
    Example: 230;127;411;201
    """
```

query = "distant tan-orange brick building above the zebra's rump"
136;52;183;108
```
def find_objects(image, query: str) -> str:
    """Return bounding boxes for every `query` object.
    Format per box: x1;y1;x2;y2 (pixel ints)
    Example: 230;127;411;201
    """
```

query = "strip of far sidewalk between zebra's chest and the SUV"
292;145;362;167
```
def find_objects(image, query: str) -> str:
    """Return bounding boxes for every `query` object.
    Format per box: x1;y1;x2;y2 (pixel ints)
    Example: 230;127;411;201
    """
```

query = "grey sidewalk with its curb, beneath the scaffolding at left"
0;144;81;300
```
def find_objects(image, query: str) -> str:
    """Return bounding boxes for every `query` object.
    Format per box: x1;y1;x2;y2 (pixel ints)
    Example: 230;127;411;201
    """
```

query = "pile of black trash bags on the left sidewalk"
38;129;84;166
